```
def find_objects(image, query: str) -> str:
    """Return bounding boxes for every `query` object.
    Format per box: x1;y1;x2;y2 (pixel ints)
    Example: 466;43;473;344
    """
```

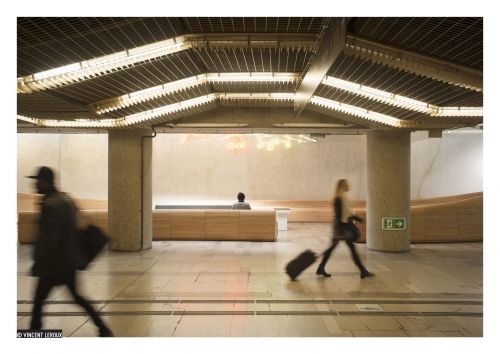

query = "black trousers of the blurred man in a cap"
30;271;103;329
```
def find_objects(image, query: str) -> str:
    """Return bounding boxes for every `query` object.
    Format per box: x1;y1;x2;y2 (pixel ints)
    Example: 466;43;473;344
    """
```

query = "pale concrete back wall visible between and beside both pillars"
17;134;483;205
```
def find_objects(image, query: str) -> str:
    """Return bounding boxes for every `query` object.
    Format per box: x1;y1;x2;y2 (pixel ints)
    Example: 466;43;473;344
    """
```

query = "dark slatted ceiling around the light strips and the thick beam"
17;17;483;131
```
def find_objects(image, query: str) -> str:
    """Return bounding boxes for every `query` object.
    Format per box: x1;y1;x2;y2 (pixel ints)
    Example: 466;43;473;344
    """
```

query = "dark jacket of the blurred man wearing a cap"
32;188;82;277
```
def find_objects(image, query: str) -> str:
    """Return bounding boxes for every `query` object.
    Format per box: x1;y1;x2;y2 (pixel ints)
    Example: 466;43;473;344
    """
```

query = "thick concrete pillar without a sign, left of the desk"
108;129;153;251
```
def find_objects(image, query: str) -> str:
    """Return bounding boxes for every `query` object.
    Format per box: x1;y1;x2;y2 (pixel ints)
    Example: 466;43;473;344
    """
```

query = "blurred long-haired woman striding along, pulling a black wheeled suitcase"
316;179;373;279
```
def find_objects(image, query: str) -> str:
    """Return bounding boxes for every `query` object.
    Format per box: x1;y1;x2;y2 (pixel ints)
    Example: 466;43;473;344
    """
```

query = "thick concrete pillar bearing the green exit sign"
366;131;411;252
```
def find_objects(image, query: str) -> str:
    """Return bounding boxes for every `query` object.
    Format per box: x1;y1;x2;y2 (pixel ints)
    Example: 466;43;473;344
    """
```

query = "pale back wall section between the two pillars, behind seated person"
153;134;366;205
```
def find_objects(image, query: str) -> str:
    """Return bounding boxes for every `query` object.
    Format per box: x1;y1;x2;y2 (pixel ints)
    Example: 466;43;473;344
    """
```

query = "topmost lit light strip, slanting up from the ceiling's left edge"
17;37;191;93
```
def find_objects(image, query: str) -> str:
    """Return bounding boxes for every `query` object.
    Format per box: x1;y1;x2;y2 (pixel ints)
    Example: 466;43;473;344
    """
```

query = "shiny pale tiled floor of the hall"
17;223;483;337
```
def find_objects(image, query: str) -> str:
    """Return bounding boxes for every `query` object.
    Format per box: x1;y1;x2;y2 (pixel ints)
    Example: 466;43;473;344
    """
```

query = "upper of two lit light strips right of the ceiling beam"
322;76;483;117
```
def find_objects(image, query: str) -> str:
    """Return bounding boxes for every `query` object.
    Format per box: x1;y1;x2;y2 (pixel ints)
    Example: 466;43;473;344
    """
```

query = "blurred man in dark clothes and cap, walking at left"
28;166;113;337
